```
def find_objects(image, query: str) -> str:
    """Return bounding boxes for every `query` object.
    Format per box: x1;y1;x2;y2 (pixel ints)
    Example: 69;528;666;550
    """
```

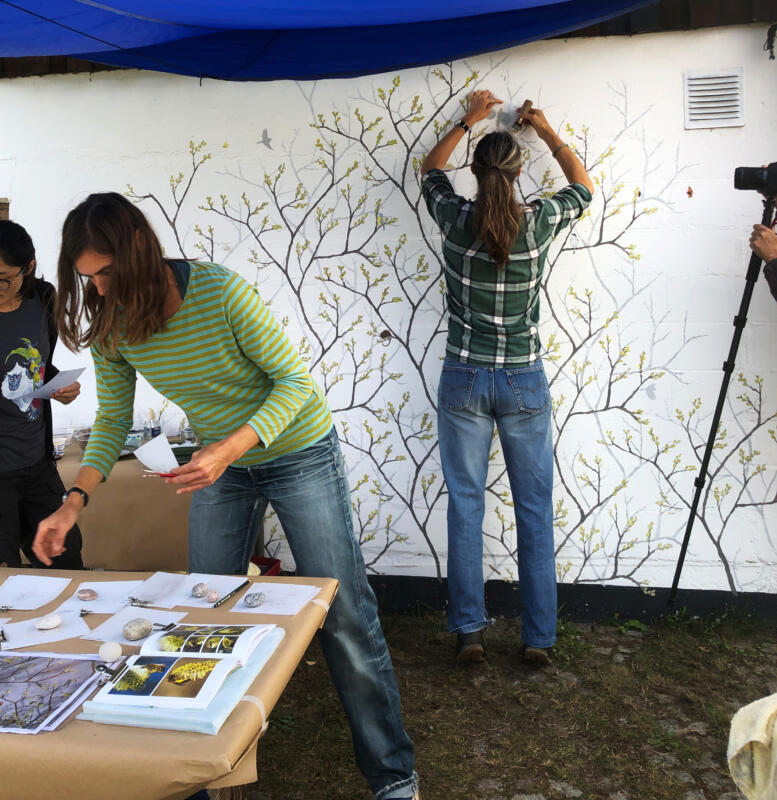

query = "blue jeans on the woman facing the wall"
437;359;557;647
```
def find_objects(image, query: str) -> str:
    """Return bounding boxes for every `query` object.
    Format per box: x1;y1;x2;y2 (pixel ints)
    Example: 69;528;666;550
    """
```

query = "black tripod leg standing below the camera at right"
667;195;775;606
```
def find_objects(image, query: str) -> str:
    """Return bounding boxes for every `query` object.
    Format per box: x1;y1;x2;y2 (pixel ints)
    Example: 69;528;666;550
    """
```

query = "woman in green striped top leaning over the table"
33;193;417;800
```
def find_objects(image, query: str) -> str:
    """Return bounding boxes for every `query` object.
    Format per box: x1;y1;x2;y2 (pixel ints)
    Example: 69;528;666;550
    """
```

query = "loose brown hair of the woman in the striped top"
57;192;167;353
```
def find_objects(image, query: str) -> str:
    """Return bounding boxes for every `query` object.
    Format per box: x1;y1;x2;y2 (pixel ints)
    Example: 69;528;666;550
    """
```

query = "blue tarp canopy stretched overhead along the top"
0;0;655;80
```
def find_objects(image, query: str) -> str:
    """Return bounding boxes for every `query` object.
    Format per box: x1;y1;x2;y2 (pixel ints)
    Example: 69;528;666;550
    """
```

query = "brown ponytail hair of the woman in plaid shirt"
472;131;523;267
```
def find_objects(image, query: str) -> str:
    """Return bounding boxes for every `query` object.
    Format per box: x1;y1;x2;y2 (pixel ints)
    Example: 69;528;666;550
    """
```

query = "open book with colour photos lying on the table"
94;623;275;709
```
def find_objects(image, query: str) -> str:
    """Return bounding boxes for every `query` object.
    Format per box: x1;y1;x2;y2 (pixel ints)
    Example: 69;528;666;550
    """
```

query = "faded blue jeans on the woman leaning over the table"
189;428;416;798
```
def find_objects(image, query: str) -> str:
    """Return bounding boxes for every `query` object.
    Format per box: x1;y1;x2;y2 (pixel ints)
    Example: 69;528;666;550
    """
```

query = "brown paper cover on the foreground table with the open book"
0;568;338;800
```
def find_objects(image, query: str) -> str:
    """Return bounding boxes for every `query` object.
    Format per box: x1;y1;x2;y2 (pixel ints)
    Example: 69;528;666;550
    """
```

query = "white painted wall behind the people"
0;26;777;592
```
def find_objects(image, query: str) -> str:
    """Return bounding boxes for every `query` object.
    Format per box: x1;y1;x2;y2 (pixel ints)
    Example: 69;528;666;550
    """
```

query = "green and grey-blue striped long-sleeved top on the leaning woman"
81;262;332;477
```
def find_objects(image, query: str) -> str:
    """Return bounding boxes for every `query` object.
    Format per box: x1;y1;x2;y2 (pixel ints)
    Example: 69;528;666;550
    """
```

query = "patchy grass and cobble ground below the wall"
239;612;777;800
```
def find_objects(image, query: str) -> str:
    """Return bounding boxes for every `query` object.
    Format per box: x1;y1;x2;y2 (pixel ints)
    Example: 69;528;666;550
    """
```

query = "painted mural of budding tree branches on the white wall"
128;61;777;588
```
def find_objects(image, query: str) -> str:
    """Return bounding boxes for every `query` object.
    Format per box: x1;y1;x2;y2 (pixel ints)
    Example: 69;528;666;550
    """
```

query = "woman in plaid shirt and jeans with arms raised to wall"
420;91;594;665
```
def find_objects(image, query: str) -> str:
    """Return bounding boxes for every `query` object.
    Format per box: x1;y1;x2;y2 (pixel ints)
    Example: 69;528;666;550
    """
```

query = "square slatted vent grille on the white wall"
683;67;745;128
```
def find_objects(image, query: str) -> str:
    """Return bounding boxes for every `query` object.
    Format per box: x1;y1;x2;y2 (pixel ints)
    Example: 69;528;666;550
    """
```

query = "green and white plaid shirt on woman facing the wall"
421;169;591;367
